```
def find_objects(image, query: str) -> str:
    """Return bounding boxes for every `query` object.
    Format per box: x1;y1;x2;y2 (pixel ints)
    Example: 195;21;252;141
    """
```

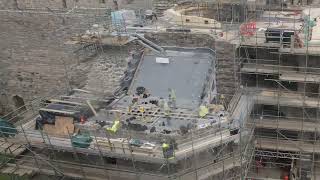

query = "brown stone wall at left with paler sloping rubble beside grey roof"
0;7;141;115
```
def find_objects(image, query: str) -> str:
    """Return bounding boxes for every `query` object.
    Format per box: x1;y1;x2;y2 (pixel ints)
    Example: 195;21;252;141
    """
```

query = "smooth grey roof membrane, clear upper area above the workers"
132;50;213;108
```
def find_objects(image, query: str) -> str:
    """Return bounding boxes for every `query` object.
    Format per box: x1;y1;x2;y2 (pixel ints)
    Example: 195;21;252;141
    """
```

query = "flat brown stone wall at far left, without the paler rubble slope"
0;12;100;114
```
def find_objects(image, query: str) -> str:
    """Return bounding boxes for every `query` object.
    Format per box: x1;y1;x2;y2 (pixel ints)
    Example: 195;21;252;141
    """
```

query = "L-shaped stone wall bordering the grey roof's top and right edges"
145;33;239;102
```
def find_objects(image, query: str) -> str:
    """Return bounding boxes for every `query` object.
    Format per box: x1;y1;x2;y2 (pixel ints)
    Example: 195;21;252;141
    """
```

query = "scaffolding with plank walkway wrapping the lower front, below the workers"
1;88;252;179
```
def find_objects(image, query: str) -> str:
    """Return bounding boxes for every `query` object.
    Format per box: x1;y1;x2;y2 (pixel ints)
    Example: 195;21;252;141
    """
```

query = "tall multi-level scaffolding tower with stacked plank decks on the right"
237;1;319;179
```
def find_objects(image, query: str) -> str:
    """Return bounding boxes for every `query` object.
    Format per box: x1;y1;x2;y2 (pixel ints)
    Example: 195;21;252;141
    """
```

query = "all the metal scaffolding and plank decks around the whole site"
0;1;320;179
